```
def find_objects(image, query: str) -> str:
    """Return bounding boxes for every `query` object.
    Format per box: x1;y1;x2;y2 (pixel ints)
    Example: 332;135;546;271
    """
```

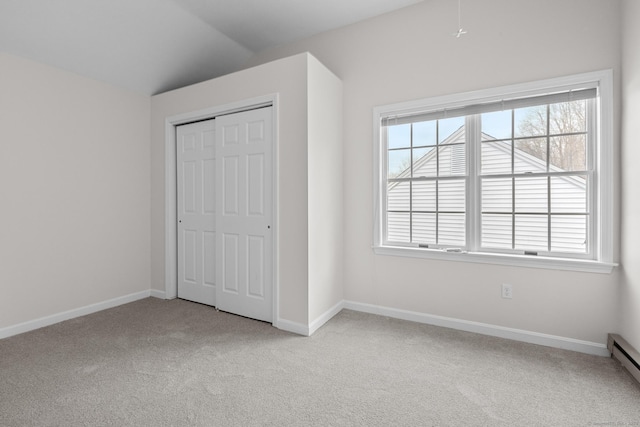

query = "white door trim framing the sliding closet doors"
164;93;280;327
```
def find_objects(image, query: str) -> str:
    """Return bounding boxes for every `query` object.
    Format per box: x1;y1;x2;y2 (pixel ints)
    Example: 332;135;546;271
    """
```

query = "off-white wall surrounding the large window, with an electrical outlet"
250;0;620;344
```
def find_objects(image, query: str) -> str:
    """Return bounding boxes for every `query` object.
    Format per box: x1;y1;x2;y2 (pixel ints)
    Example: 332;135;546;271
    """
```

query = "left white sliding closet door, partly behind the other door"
176;119;216;305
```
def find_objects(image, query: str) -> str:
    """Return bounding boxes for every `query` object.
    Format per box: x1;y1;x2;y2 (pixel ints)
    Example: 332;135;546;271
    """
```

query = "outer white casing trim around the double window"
373;70;617;273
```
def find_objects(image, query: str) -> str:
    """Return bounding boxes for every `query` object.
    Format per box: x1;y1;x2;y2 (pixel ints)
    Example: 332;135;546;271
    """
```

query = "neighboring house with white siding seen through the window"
387;126;588;253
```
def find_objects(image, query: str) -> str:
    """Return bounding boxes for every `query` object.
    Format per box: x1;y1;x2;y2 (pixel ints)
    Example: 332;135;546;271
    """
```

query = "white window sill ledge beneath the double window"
373;246;618;274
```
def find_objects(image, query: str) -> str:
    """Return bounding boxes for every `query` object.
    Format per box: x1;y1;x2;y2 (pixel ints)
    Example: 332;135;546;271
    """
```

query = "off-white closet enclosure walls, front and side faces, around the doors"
151;54;344;333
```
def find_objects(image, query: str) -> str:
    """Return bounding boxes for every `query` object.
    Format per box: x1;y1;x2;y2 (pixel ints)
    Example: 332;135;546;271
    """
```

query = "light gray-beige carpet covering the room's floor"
0;298;640;427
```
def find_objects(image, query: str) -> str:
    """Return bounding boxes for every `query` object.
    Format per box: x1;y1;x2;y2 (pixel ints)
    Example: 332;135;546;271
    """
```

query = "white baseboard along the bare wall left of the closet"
0;290;151;339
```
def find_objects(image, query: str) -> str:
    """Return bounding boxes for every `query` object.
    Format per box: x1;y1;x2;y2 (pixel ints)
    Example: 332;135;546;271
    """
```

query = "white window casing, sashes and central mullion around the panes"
372;70;619;274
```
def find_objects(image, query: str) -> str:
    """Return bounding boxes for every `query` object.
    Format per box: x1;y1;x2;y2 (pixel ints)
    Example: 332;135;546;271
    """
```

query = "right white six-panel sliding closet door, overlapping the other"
216;107;273;322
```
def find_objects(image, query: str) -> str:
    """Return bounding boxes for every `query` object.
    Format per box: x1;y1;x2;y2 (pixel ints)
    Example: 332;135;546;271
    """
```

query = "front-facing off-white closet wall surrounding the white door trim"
151;55;308;325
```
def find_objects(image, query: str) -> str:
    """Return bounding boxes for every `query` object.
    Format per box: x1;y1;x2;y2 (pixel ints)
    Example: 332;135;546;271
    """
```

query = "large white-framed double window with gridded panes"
374;71;613;271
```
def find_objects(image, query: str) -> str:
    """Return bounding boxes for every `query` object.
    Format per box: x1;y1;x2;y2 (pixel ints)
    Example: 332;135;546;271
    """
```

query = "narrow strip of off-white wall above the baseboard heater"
619;0;640;349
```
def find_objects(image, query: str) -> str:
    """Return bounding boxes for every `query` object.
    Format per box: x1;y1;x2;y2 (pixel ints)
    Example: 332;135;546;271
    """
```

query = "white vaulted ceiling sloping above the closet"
0;0;422;95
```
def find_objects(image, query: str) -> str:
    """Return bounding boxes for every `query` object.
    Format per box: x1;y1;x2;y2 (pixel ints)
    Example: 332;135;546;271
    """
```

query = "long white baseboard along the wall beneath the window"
344;301;611;357
